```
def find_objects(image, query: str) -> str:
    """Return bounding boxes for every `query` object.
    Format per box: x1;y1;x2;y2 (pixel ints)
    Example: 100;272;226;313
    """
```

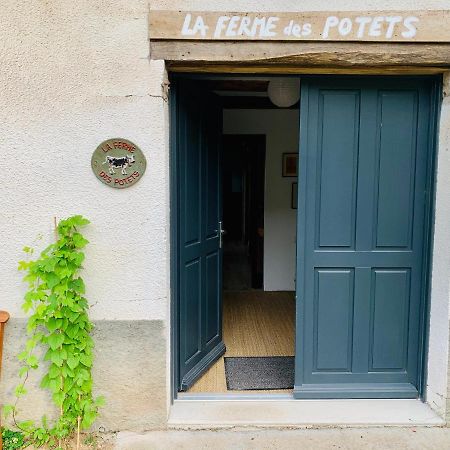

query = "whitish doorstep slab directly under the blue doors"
168;394;445;429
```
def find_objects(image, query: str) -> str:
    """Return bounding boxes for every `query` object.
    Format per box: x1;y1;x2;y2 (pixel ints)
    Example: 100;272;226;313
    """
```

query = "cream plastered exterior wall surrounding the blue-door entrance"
0;0;450;430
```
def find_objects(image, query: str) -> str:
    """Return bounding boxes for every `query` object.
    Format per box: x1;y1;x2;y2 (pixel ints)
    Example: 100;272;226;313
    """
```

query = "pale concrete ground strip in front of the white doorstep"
114;427;450;450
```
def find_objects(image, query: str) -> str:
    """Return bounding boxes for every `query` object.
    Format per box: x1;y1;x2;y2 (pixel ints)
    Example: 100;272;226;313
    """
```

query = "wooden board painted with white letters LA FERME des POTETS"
150;10;450;42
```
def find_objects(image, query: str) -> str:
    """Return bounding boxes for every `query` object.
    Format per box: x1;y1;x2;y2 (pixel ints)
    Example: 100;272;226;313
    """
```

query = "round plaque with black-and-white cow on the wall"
91;138;147;189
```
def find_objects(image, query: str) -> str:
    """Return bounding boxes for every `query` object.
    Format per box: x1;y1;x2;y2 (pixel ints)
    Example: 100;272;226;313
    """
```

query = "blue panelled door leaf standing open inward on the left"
176;81;225;390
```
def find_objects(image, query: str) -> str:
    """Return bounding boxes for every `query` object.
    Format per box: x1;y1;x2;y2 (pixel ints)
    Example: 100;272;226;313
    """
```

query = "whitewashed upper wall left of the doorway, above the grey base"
0;0;169;320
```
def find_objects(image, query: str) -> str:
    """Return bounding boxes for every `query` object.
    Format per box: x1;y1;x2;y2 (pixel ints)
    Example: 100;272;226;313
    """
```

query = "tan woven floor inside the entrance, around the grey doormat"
189;290;295;394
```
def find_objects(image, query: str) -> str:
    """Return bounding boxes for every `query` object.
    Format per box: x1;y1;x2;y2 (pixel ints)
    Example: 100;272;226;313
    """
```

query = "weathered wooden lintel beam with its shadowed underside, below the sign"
150;41;450;74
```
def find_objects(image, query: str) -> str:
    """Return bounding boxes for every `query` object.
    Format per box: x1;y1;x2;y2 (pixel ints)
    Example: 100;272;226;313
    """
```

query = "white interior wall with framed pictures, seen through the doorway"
223;109;299;291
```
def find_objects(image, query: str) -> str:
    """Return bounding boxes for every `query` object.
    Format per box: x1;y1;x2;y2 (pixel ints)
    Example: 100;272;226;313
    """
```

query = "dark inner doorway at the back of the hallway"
222;135;265;291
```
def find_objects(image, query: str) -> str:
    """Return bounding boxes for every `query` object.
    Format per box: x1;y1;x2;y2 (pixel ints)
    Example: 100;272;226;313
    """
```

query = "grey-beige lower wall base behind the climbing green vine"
0;319;167;431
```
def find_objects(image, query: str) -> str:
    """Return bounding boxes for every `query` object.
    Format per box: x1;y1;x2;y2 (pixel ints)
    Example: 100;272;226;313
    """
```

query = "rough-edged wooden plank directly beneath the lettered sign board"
150;41;450;67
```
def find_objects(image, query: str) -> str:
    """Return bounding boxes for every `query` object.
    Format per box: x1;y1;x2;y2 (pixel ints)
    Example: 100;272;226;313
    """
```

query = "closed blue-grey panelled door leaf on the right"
294;77;432;398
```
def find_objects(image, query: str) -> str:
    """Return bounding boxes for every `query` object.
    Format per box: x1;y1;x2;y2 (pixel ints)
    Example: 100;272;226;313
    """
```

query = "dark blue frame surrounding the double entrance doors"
168;72;443;404
